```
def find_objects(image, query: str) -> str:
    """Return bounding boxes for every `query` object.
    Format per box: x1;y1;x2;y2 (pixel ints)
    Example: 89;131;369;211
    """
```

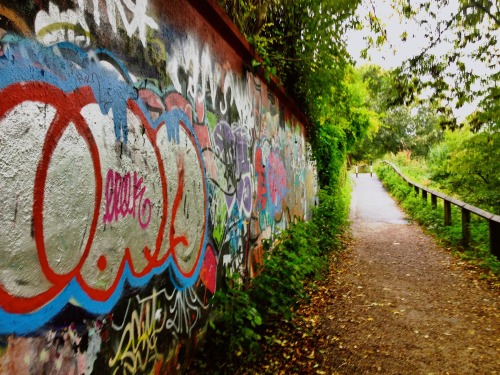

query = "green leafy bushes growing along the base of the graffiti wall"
194;173;350;373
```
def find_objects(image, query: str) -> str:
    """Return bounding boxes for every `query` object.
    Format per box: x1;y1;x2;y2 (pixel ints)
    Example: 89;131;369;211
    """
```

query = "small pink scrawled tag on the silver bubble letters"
103;169;151;229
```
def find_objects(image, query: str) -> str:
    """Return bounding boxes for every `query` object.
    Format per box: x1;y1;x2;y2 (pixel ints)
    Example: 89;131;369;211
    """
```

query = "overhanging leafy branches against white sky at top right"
369;0;500;131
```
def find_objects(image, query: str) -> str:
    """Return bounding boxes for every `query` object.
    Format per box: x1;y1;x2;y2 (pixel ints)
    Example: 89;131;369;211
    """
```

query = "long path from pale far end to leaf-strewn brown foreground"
321;174;500;374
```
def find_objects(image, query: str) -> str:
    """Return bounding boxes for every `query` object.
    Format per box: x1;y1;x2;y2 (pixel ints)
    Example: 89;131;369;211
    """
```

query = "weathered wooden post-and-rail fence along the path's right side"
383;160;500;259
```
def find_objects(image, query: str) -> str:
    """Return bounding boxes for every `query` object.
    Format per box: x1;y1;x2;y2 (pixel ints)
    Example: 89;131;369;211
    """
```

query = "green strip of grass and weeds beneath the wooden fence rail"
375;164;500;276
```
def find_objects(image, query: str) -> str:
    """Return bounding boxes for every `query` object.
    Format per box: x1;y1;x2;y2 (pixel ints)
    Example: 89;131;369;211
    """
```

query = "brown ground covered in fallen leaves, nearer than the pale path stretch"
238;223;500;375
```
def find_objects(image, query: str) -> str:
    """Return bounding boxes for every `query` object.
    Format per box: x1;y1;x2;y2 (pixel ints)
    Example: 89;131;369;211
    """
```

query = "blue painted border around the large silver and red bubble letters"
0;34;209;335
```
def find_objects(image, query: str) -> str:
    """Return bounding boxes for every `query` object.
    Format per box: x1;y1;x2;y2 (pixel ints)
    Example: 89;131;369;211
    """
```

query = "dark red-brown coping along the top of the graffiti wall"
187;0;310;129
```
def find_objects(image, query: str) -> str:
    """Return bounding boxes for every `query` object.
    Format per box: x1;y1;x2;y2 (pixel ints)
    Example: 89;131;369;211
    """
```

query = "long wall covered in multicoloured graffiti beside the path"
0;0;316;375
